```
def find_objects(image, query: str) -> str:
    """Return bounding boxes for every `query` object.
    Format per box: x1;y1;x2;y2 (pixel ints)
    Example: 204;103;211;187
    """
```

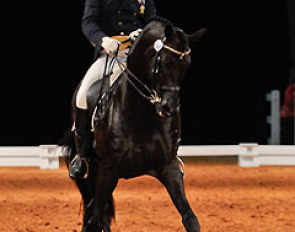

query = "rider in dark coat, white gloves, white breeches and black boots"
69;0;156;179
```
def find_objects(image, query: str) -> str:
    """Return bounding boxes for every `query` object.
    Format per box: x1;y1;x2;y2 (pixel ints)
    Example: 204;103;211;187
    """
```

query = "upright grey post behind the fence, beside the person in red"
266;90;281;145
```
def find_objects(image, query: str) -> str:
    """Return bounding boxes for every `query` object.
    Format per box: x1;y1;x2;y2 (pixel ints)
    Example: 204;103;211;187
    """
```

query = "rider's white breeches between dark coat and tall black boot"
76;50;128;109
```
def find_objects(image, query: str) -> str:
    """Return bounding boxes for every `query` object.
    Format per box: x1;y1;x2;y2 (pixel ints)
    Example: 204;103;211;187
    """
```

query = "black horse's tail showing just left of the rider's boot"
58;130;76;168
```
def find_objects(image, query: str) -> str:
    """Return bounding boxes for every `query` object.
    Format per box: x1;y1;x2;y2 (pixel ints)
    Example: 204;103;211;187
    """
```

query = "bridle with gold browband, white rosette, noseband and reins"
117;37;191;104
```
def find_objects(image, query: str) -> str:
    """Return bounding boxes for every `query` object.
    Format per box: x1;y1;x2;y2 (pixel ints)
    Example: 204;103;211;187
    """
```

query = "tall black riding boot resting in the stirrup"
69;108;92;179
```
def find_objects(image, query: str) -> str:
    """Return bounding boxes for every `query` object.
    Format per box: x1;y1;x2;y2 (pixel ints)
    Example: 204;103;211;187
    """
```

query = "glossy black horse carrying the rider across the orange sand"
61;18;205;232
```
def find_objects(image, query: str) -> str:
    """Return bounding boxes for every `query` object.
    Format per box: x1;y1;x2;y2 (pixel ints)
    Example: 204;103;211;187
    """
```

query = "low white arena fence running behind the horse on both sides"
0;143;295;169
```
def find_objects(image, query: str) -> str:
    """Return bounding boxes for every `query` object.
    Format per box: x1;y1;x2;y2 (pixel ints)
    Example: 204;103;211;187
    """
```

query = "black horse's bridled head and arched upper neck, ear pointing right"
127;18;205;117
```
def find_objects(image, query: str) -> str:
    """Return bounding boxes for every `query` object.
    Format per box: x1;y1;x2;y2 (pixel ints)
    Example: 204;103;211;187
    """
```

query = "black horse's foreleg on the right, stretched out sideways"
157;160;200;232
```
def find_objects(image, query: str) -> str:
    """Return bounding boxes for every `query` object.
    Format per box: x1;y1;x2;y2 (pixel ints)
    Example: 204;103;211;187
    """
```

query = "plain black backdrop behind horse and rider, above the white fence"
0;0;290;146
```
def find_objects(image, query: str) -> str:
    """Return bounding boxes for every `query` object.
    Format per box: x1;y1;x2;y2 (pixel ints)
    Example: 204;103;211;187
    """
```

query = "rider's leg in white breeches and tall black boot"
69;56;105;179
